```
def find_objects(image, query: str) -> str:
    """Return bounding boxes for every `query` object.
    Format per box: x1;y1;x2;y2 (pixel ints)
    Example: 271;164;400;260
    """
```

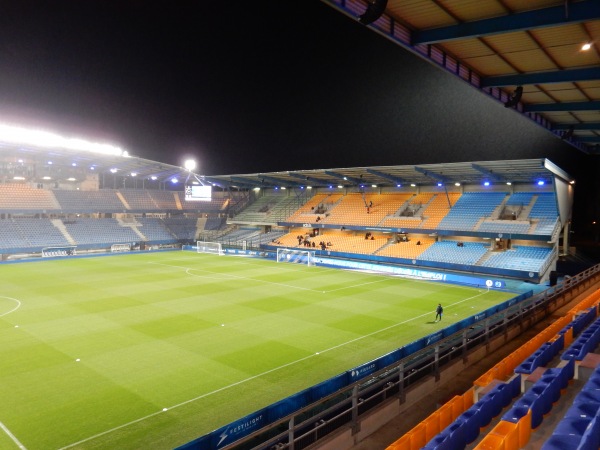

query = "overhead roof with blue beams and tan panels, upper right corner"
323;0;600;154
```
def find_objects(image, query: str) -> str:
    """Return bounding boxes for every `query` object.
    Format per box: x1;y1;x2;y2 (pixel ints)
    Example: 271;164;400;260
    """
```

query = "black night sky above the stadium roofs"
0;0;600;236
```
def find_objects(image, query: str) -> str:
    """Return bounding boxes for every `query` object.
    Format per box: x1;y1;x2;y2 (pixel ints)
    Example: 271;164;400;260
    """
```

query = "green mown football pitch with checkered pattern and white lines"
0;251;514;450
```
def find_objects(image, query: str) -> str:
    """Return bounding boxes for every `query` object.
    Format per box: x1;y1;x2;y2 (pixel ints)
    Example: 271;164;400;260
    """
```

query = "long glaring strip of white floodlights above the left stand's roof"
0;124;123;156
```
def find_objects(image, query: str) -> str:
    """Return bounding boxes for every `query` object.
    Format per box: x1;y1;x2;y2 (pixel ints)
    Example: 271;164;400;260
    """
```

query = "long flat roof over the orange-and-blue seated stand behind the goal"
205;159;573;188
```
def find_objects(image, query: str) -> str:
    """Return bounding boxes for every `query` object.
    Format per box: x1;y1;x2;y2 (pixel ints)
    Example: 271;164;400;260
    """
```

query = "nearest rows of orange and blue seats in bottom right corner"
387;291;600;450
